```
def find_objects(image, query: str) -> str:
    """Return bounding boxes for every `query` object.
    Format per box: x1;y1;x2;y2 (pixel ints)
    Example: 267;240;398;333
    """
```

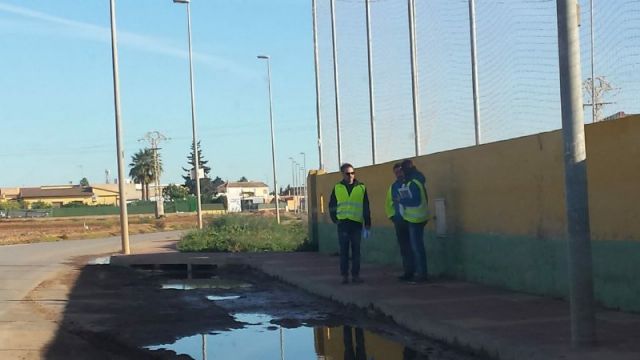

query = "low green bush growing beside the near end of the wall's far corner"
178;215;309;252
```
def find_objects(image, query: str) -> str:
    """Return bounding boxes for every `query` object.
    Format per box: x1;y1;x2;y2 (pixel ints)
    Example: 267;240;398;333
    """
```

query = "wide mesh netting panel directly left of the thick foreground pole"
477;0;561;142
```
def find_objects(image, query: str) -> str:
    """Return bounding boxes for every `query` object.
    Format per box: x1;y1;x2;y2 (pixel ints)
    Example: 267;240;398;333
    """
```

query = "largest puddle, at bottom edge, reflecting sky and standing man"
147;314;429;360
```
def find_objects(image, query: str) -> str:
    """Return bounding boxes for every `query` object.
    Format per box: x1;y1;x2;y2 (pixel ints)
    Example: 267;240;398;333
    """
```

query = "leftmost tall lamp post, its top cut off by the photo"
110;0;131;255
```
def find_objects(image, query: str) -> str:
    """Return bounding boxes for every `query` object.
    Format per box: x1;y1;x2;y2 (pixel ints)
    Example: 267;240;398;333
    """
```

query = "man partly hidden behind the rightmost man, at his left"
384;163;416;281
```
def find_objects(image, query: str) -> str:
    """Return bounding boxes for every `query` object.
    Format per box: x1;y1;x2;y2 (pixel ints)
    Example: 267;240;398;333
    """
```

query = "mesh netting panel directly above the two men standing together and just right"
416;0;475;153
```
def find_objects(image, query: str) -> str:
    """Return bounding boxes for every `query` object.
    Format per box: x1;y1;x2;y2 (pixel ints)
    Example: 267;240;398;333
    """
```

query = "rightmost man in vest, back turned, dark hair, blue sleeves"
398;160;429;282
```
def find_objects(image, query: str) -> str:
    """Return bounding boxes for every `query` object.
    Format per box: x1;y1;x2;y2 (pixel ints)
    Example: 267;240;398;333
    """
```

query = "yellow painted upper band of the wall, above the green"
315;115;640;240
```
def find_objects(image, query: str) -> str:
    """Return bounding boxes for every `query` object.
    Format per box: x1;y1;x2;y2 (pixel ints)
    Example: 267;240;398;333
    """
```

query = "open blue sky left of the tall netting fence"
0;0;317;186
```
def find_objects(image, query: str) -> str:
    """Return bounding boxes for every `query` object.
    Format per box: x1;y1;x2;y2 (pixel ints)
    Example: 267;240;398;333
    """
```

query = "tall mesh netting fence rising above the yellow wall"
316;0;640;170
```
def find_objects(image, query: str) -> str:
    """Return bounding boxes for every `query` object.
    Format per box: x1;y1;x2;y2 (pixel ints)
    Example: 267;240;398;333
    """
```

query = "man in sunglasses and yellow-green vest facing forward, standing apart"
329;163;371;284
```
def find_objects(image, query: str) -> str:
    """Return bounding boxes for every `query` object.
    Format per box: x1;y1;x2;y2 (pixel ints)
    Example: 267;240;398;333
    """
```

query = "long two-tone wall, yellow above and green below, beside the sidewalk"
309;116;640;311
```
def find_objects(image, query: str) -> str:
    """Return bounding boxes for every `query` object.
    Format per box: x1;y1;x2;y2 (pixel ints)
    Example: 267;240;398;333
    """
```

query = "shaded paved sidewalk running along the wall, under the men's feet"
111;253;640;360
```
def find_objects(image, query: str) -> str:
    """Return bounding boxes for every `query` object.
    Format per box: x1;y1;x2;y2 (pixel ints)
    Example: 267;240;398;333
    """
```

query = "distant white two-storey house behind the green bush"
216;181;271;212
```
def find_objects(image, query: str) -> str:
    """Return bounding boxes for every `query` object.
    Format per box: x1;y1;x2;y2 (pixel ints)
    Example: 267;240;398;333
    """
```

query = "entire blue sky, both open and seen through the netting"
0;0;640;186
